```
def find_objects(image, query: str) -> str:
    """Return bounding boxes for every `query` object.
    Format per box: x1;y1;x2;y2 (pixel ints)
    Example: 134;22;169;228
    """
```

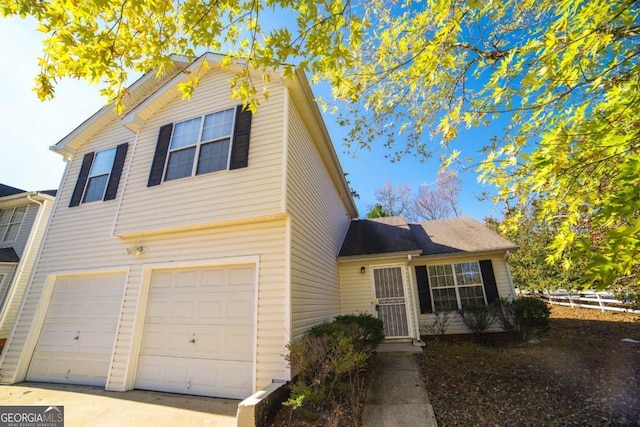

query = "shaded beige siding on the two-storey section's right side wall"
287;96;350;339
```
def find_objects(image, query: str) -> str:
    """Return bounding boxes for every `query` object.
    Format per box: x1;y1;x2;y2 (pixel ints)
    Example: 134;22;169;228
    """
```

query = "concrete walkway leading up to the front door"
362;343;438;427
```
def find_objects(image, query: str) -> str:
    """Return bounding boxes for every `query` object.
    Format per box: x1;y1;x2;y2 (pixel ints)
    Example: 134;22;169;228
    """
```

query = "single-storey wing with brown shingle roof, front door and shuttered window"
338;217;517;340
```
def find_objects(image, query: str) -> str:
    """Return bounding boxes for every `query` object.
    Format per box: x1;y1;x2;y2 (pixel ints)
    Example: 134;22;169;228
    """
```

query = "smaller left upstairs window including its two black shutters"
69;143;129;207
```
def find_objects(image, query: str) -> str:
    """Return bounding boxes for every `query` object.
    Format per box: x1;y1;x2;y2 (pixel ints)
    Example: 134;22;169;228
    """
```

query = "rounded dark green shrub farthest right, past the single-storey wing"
494;297;550;341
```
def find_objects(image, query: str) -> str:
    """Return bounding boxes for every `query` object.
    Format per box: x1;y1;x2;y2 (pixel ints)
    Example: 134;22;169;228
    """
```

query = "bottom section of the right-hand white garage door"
135;356;252;399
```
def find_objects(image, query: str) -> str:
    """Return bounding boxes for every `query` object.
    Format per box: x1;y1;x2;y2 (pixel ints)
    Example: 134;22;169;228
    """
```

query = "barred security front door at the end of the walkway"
373;267;409;338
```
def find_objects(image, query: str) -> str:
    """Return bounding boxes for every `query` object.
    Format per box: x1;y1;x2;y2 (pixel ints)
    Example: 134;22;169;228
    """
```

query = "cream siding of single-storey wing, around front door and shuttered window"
339;254;512;335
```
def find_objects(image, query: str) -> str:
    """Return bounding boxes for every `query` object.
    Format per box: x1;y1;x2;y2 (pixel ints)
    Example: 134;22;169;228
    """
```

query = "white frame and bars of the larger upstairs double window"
161;107;238;182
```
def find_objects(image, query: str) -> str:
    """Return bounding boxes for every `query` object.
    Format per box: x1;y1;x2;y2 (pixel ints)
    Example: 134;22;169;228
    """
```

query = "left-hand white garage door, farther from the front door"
26;273;125;387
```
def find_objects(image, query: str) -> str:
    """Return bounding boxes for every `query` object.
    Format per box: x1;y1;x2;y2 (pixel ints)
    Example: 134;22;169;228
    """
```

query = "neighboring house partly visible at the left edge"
0;184;56;350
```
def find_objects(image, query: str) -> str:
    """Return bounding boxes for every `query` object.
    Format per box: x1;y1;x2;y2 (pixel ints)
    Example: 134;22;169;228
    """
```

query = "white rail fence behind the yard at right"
522;289;640;313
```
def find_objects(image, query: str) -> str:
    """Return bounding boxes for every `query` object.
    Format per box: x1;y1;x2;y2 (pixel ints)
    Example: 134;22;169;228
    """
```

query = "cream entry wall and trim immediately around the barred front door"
339;257;418;337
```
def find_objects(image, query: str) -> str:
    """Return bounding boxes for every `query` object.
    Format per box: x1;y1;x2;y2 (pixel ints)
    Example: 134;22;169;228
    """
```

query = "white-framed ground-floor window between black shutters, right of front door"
428;262;486;312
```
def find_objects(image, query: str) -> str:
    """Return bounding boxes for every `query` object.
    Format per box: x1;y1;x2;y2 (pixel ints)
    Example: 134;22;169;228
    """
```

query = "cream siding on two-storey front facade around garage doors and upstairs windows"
0;67;289;390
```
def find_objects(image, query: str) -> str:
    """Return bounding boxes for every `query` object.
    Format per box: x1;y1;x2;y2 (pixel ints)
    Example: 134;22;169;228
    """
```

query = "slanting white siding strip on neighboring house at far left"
0;200;53;338
